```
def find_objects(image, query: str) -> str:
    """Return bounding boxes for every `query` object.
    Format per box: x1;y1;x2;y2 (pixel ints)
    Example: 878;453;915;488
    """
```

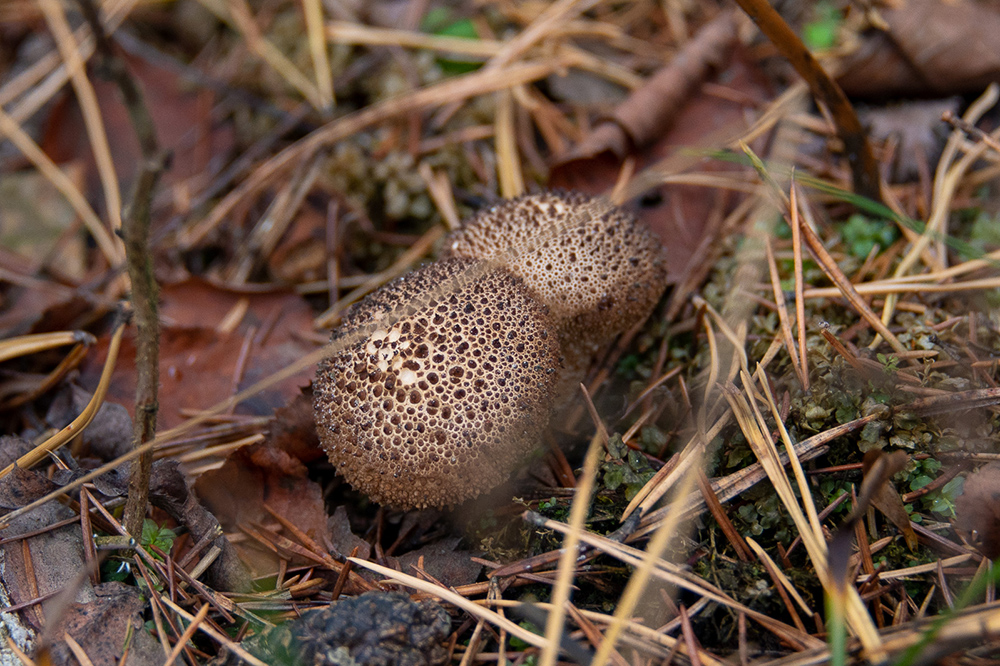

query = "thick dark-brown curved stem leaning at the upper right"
736;0;882;202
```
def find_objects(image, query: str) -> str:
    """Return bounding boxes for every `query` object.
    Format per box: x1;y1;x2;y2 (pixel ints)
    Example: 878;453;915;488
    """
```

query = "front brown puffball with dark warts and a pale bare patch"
313;259;559;508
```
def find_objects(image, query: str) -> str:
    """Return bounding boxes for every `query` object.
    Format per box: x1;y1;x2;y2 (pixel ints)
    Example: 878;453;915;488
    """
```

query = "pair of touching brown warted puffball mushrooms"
314;192;666;508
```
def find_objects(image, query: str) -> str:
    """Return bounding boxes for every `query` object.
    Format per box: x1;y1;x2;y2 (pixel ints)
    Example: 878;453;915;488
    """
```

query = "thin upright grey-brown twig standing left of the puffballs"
79;0;167;539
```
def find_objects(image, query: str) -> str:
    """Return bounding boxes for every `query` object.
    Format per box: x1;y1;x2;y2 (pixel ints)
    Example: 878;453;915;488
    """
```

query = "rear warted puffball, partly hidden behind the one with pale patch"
443;192;667;397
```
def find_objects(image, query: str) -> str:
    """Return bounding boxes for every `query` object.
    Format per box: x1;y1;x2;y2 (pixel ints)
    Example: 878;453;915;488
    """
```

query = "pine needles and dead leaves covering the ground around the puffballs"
0;0;1000;664
